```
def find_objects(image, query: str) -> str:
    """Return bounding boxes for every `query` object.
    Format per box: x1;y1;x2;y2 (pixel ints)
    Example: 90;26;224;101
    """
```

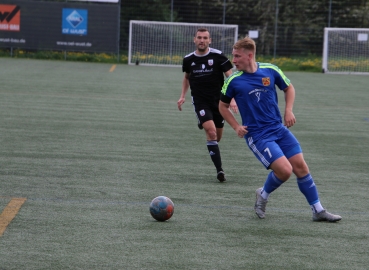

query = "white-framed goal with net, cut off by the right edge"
322;28;369;75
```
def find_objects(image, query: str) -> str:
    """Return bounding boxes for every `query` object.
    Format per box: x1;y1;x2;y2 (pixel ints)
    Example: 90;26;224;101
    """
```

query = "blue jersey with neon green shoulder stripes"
221;63;290;141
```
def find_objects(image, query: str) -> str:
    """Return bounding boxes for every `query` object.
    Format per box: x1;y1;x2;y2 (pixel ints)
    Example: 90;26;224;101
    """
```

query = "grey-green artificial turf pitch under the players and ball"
0;58;369;270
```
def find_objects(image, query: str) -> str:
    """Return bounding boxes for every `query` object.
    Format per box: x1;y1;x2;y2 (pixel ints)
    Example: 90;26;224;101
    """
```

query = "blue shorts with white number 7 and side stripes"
246;126;302;169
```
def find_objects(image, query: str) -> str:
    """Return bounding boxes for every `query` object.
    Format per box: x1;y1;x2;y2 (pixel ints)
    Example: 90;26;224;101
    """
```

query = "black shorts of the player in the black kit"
192;97;224;129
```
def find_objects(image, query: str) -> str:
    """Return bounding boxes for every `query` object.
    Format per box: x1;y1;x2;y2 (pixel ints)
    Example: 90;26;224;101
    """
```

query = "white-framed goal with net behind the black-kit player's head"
128;20;238;66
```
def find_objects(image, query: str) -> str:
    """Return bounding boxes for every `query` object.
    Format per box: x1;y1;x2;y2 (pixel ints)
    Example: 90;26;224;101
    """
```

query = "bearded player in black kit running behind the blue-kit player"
177;28;238;182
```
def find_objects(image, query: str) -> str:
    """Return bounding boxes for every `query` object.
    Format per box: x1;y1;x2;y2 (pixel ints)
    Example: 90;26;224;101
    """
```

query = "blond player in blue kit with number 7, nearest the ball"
219;37;341;222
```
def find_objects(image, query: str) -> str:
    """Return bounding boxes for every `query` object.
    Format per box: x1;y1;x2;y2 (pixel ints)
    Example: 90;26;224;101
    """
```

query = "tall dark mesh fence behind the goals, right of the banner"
120;0;369;56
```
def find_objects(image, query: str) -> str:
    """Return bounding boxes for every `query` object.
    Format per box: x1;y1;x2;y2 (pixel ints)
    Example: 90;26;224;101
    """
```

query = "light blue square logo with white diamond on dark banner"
62;8;88;36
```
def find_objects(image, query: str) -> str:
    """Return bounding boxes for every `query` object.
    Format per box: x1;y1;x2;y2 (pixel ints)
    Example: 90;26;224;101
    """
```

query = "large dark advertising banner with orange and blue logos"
0;0;120;53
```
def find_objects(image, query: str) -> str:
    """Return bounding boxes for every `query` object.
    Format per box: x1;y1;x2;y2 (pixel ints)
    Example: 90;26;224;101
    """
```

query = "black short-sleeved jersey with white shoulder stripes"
182;48;233;100
